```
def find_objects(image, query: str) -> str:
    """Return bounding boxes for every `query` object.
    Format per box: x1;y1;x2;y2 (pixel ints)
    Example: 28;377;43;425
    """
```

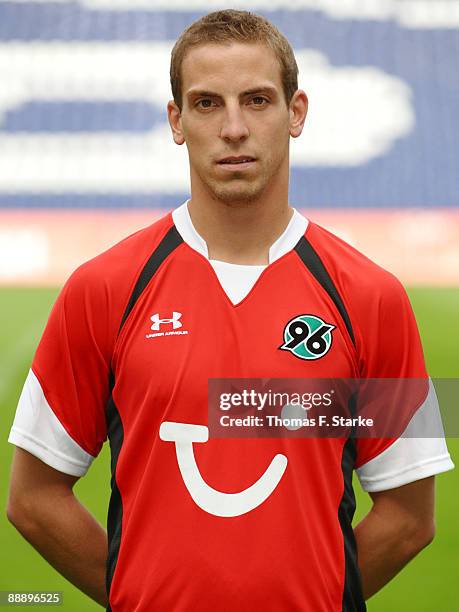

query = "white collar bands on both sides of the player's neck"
172;200;308;263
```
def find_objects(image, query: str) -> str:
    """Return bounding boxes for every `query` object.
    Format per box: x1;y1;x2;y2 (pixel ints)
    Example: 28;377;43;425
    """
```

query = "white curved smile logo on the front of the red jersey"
159;422;287;517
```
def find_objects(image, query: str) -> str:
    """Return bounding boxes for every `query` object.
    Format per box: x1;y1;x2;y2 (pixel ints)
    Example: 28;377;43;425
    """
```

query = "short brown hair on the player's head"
170;9;298;110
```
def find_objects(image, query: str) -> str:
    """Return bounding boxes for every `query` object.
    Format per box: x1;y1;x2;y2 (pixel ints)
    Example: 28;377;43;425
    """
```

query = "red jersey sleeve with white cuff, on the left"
9;264;113;476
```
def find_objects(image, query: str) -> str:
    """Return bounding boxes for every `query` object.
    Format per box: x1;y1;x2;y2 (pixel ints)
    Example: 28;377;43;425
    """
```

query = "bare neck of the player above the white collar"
188;179;293;265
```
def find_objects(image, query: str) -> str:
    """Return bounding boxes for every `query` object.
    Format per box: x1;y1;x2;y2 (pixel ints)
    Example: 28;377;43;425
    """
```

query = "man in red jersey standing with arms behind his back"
8;10;452;612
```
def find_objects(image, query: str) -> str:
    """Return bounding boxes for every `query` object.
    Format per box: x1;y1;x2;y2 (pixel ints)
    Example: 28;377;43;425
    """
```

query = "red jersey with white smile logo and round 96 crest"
23;209;434;612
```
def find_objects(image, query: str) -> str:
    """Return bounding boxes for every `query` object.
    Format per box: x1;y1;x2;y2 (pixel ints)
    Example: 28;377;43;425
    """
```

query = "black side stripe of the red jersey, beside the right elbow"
338;438;367;612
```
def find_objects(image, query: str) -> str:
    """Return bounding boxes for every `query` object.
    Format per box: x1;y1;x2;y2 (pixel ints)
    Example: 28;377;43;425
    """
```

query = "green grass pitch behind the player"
0;289;459;612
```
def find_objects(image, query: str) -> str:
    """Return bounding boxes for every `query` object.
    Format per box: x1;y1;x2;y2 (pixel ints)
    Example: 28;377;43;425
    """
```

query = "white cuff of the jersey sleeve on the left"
8;370;94;476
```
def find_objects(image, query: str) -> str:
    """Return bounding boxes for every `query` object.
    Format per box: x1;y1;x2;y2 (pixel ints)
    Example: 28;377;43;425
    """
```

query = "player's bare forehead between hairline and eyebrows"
182;43;282;96
